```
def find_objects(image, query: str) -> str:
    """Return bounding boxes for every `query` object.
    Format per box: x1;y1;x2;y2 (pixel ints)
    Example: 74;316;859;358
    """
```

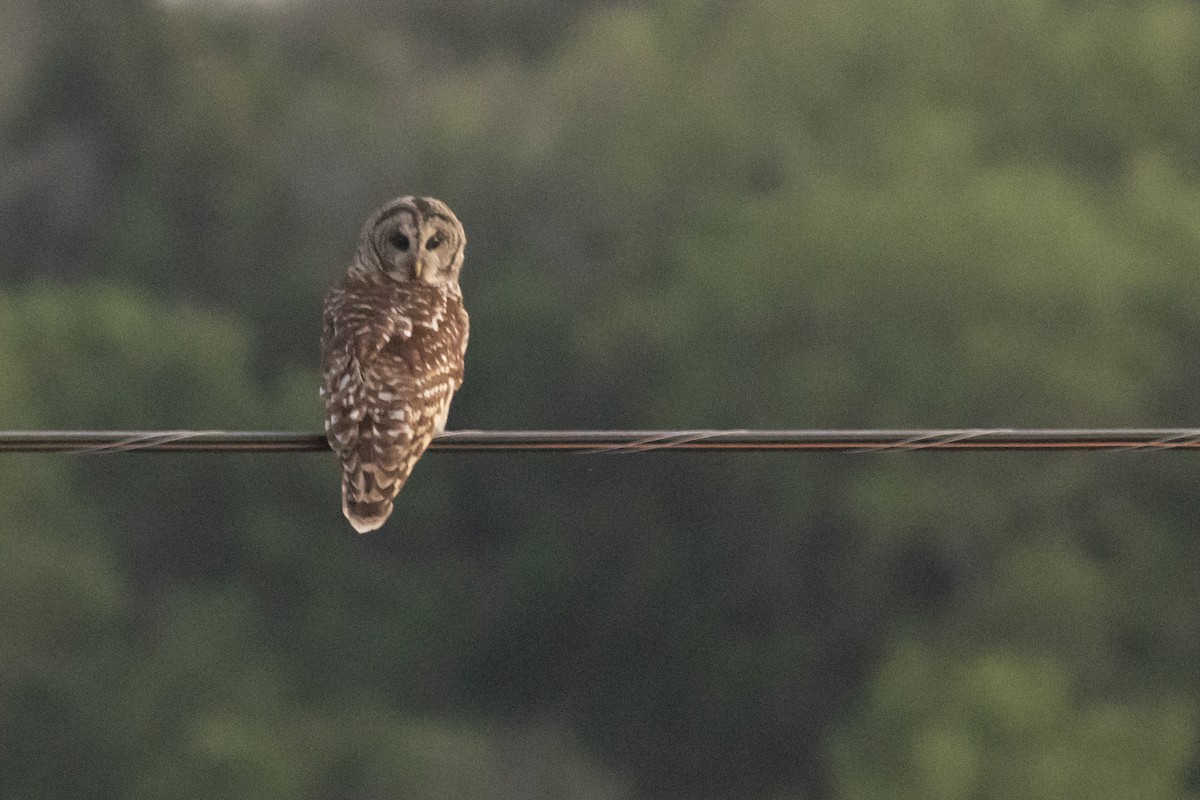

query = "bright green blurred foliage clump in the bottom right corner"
833;642;1195;800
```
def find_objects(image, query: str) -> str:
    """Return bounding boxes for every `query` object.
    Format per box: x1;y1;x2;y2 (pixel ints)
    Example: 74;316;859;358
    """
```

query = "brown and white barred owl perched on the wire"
320;197;468;534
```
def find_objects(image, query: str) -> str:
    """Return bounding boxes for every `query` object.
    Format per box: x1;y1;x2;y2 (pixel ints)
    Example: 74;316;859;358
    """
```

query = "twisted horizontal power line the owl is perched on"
7;428;1200;452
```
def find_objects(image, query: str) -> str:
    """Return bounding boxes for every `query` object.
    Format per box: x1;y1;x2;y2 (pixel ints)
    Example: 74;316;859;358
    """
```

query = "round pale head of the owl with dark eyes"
350;196;467;287
